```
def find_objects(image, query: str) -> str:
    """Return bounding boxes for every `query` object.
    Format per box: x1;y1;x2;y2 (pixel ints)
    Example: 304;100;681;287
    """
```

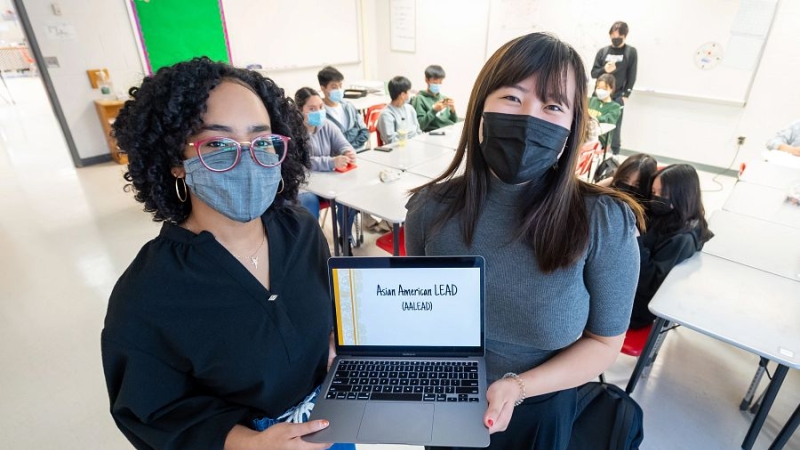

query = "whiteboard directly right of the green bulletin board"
222;0;361;71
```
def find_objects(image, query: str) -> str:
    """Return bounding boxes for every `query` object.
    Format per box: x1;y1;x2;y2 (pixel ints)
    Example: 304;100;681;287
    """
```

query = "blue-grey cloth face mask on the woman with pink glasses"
183;149;281;223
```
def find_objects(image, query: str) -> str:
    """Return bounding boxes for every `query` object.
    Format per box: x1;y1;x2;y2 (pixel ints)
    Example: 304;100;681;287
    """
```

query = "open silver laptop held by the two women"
304;256;489;447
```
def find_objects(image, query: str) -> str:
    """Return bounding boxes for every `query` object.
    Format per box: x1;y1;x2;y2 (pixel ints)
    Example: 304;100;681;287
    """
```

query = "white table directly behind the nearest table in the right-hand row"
703;210;800;282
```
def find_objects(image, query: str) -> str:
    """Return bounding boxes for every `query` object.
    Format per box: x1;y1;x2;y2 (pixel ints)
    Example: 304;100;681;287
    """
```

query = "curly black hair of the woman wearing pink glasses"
112;57;311;223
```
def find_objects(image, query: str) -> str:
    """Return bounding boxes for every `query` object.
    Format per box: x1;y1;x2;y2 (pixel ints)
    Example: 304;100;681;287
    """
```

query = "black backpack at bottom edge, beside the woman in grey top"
567;382;644;450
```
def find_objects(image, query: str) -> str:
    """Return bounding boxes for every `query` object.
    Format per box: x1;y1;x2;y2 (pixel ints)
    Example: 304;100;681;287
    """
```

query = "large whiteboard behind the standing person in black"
486;0;777;106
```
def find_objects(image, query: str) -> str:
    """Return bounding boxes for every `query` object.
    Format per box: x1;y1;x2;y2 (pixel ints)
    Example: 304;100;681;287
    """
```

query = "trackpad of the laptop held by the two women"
358;402;434;444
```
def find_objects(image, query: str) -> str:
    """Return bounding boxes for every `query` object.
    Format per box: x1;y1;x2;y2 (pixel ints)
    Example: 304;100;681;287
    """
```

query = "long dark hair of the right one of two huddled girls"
649;164;714;242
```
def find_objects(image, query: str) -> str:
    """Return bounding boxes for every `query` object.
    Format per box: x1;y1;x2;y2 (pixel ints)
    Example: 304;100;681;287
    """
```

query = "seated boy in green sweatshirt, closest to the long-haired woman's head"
411;66;458;132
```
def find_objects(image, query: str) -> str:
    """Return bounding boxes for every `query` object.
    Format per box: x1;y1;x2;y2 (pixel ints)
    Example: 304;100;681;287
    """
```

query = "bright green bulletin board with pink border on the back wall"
130;0;230;73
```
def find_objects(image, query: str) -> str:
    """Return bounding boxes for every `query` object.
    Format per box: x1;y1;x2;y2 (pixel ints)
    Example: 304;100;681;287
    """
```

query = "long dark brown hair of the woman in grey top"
412;33;644;273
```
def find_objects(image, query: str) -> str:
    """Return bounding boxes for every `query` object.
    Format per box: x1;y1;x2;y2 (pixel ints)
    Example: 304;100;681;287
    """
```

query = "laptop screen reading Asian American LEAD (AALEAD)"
330;257;483;351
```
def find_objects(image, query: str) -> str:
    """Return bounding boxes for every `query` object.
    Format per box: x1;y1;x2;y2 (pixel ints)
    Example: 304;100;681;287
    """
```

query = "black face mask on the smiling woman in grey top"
480;113;569;184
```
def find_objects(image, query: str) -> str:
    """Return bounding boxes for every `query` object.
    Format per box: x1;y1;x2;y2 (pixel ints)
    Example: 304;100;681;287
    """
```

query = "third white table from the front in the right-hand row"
712;182;800;231
